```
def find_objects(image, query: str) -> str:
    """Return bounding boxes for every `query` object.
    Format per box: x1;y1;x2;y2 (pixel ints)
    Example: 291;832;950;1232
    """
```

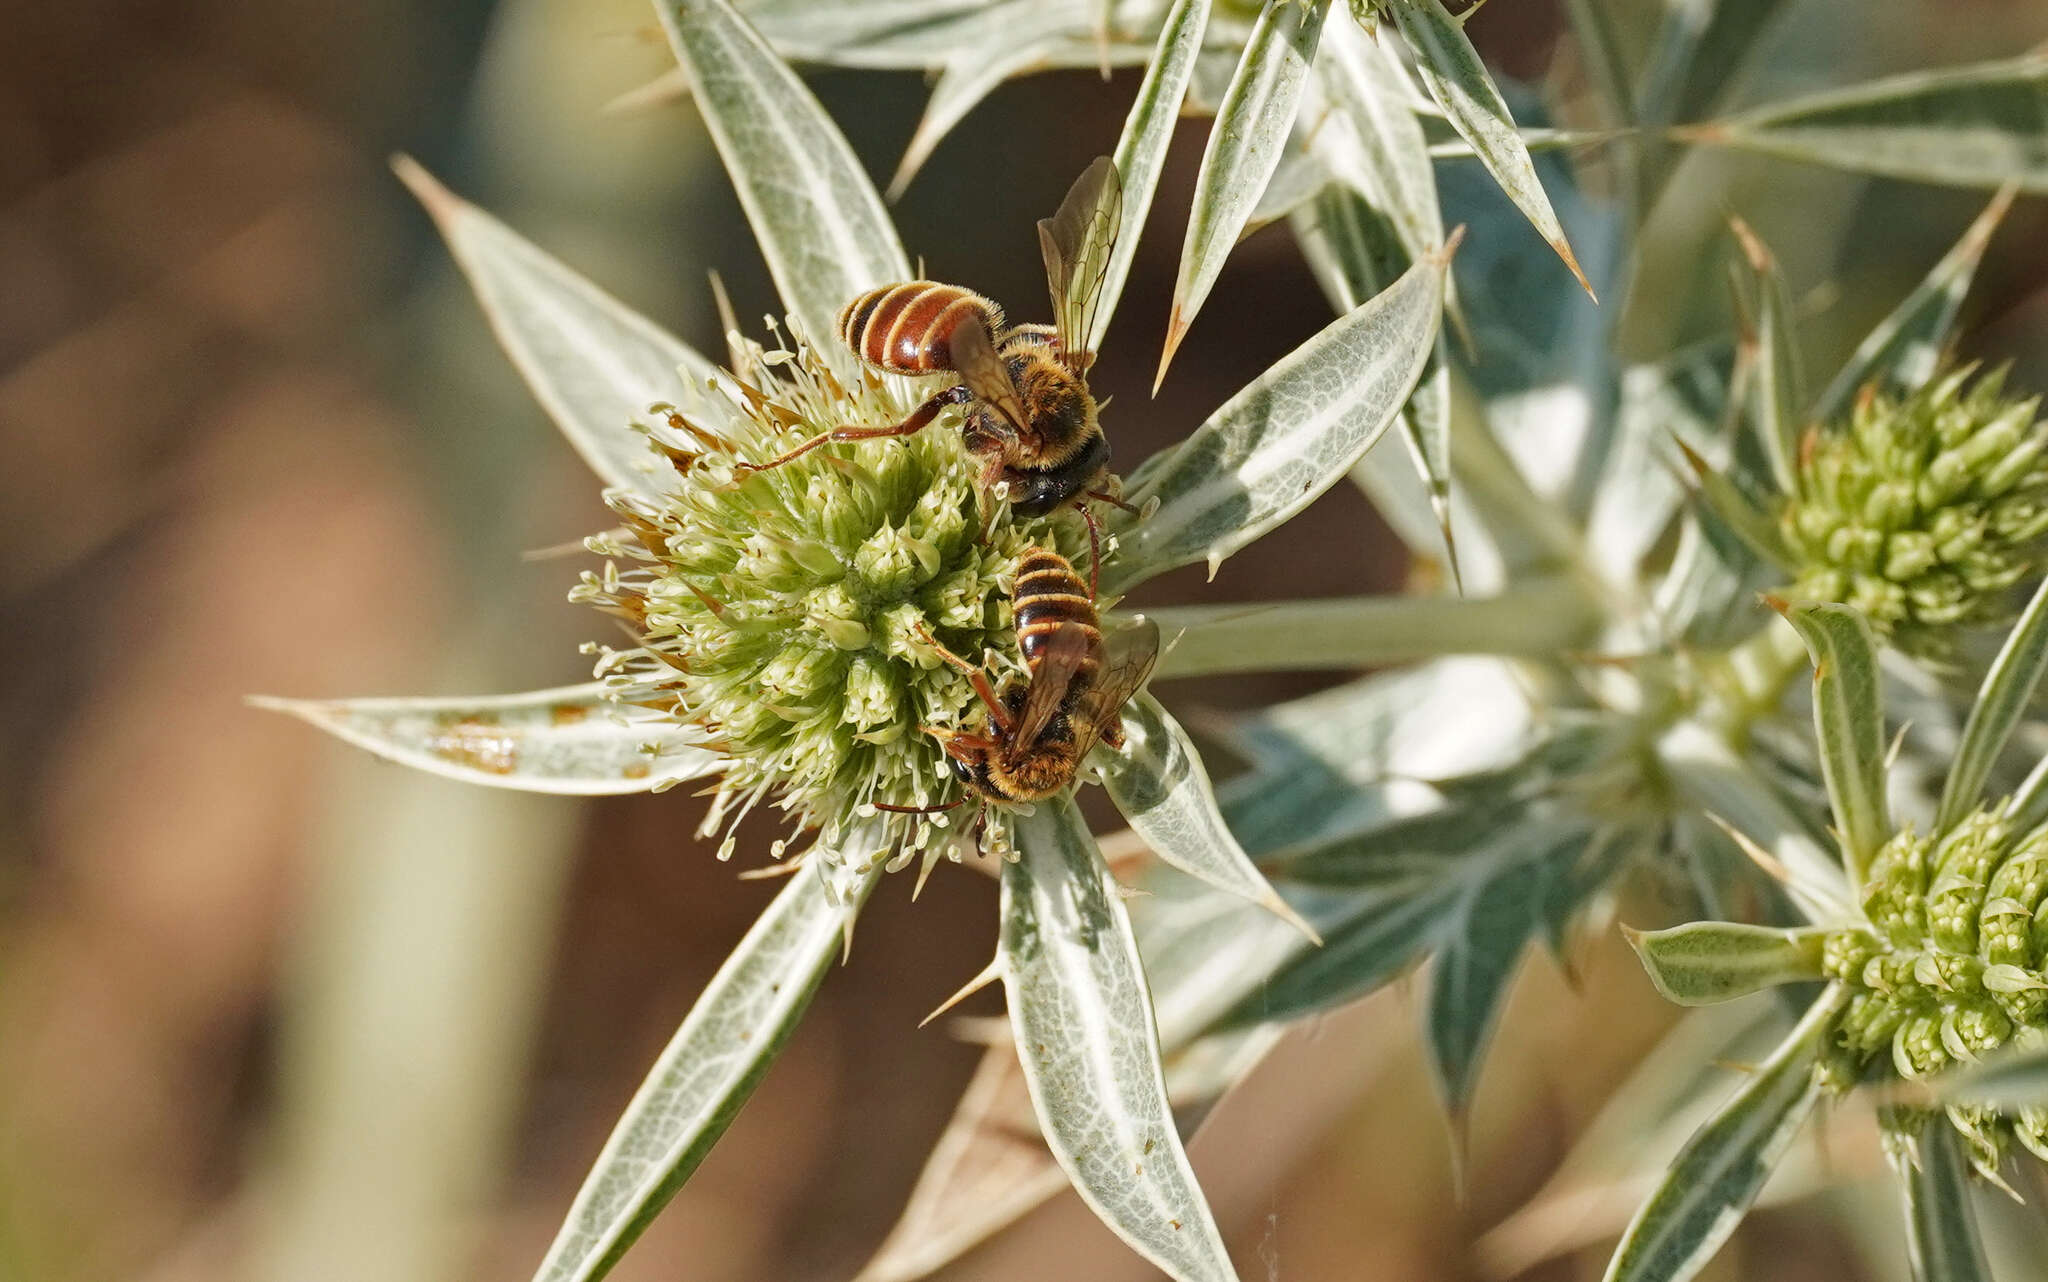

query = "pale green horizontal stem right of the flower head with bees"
1151;575;1599;676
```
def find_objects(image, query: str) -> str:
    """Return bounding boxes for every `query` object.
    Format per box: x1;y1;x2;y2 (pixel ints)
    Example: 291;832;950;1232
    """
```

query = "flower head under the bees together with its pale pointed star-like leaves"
256;0;1450;1282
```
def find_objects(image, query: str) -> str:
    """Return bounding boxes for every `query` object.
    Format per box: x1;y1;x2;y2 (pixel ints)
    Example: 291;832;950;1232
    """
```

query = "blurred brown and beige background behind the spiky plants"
0;0;2048;1282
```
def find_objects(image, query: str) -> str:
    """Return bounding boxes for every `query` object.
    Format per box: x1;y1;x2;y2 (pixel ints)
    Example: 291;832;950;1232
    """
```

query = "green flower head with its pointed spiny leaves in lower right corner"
1608;588;2048;1282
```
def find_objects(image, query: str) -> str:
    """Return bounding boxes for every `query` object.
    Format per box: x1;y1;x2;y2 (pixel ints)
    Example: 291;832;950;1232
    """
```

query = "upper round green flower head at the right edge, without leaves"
1780;367;2048;659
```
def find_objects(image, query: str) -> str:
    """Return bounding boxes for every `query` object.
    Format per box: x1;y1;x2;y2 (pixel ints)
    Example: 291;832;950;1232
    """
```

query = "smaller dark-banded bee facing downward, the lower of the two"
879;547;1159;835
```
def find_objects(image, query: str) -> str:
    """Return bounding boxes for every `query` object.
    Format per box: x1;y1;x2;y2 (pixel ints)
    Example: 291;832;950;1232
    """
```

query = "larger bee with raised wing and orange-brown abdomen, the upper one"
739;156;1128;557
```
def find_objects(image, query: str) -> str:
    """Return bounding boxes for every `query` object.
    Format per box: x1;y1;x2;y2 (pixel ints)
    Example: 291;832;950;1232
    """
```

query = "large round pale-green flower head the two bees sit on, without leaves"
571;317;1079;866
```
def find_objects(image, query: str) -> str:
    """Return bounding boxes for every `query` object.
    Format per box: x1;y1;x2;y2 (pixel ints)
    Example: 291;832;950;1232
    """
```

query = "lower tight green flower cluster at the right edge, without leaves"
1823;803;2048;1176
